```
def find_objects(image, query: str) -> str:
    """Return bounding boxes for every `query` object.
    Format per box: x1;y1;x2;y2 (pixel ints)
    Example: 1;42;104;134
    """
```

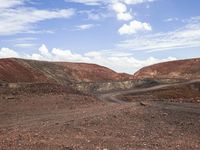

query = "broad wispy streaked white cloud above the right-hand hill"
117;18;200;52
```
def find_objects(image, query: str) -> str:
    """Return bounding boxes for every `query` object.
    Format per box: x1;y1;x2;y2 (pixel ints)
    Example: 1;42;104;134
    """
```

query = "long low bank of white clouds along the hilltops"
0;44;176;74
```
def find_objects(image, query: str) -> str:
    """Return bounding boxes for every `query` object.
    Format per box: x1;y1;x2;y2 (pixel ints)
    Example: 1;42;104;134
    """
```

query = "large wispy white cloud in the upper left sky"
0;4;75;35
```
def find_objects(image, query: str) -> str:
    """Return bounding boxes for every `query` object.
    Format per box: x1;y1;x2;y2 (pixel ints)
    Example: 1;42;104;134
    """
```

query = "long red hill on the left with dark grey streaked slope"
0;58;133;84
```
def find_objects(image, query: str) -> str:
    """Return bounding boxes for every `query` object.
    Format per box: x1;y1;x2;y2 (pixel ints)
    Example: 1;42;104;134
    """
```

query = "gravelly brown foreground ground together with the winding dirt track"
0;80;200;150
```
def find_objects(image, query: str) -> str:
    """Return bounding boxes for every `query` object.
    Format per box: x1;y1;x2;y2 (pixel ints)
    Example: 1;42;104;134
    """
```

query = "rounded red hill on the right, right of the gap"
134;58;200;79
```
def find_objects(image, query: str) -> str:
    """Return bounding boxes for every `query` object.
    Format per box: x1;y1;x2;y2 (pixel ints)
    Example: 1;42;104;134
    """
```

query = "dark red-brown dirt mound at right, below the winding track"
119;82;200;103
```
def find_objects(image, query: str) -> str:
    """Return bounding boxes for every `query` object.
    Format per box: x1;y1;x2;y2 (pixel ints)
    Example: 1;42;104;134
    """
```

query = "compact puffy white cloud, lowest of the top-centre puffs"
118;20;152;35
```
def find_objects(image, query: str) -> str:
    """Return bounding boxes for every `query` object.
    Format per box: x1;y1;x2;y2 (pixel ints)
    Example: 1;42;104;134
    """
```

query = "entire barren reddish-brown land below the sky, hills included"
0;58;200;150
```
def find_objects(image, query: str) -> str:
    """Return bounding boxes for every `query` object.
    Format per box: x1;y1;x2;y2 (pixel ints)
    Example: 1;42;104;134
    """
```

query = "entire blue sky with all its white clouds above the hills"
0;0;200;73
